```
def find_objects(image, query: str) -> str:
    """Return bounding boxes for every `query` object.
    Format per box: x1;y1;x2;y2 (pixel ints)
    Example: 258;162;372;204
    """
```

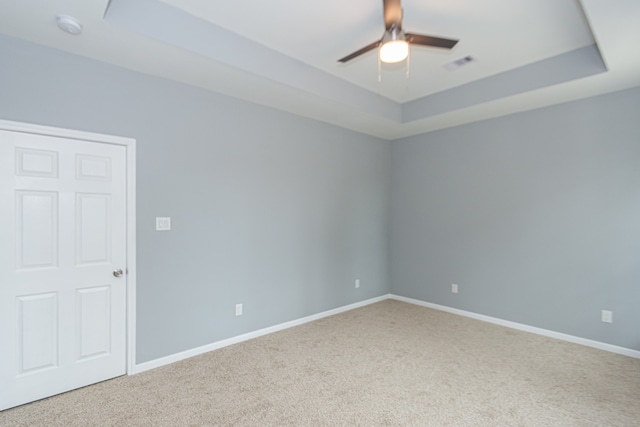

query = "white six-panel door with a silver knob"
0;130;127;410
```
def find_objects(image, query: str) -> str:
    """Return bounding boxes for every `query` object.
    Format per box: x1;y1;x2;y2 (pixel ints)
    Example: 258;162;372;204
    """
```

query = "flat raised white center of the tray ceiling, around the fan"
162;0;594;102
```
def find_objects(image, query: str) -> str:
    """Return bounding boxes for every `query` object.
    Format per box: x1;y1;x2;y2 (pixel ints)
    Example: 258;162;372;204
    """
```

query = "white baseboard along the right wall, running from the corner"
389;294;640;359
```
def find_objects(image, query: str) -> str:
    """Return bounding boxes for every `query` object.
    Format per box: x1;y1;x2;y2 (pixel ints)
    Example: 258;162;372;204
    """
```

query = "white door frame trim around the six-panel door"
0;120;136;375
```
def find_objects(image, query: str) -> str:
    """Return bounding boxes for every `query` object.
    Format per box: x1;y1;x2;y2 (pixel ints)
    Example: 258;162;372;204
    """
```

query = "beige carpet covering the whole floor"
0;300;640;426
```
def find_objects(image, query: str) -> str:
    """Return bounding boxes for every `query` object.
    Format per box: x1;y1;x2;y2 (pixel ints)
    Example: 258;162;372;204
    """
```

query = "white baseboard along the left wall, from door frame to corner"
130;295;389;374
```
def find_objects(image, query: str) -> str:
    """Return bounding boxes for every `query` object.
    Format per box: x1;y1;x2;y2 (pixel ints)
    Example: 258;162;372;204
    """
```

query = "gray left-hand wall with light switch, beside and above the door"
0;36;390;363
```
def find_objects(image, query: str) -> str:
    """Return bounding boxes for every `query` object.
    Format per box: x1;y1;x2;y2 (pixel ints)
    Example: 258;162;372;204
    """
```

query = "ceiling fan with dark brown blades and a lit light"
338;0;458;64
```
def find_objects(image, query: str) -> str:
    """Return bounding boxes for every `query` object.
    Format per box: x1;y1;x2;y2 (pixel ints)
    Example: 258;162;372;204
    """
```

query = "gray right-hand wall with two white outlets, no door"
390;88;640;350
